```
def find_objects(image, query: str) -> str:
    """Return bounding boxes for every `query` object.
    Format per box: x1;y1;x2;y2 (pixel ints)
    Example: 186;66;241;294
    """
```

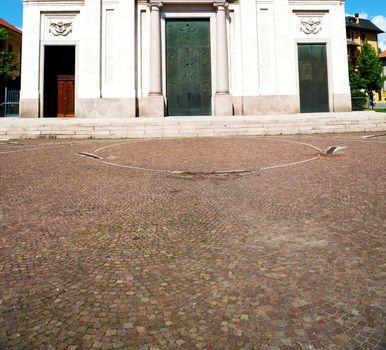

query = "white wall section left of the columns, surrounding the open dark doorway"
21;0;136;117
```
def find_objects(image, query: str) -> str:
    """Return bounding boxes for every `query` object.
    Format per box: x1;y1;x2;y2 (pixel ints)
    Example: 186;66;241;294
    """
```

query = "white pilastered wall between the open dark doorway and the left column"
76;0;136;117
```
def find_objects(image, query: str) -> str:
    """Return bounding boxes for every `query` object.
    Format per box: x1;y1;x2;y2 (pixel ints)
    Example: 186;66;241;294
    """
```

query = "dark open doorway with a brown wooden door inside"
43;46;75;118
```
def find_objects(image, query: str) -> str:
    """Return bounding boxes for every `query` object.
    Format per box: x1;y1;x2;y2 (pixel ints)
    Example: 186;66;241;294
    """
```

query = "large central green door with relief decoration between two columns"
166;19;212;116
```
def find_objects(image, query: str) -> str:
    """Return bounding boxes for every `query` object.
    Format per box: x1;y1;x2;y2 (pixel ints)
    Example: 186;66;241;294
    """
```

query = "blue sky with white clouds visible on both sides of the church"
0;0;386;50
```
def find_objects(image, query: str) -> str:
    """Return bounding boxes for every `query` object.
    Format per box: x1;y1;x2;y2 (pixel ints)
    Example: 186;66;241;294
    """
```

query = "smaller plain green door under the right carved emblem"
298;44;329;113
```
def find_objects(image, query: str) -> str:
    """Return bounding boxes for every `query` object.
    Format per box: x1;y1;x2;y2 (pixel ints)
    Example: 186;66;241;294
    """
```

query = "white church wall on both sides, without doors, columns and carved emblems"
21;0;351;117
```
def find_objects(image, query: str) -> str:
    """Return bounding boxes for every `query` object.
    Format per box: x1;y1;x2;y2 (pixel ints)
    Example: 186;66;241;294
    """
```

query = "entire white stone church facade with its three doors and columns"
20;0;351;118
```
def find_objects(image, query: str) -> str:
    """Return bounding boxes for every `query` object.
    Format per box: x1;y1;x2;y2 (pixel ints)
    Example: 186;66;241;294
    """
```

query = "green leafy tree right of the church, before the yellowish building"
357;40;386;93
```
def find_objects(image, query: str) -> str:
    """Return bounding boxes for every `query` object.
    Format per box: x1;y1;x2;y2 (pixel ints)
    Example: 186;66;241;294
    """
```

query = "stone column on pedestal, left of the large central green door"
143;0;165;117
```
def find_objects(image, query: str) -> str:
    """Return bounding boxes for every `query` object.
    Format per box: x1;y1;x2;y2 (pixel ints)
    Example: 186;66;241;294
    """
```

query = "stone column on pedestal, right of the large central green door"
213;0;233;115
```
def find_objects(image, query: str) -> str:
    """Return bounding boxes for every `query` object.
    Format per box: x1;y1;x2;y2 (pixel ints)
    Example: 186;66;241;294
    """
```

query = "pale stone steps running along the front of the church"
0;111;386;138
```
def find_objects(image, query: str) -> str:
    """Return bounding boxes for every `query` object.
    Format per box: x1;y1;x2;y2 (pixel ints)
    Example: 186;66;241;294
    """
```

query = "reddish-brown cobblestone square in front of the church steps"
0;134;386;350
